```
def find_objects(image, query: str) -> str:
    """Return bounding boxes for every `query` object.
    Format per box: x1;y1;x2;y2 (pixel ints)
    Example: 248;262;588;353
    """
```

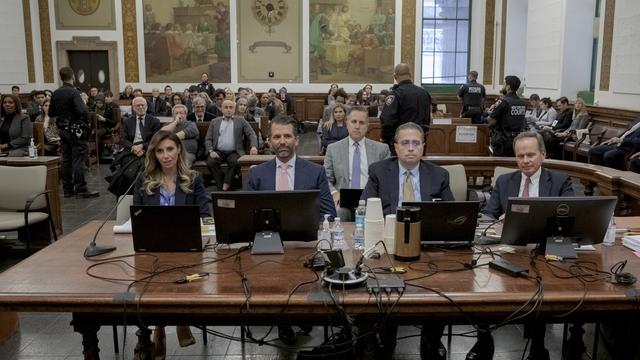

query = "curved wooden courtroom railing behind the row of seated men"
238;155;640;215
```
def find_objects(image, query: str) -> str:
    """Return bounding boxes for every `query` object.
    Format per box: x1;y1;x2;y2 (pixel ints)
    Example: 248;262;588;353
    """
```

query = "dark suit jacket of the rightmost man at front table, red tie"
481;168;574;219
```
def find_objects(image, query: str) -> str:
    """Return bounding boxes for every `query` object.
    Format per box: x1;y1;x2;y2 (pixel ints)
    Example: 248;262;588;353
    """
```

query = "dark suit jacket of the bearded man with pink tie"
247;156;336;217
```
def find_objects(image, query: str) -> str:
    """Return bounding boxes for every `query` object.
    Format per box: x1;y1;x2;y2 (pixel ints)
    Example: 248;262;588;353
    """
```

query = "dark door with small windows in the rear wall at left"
68;51;110;94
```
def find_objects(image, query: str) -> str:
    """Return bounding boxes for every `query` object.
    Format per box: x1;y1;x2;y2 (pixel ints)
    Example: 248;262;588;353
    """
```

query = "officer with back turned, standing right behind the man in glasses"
380;63;431;154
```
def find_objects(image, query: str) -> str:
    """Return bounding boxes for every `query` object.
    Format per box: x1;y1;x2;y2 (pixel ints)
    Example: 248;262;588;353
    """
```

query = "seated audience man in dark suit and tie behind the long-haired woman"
122;97;161;157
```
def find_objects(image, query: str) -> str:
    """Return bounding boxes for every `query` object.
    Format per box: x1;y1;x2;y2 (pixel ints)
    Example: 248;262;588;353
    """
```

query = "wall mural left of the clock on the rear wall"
142;0;231;84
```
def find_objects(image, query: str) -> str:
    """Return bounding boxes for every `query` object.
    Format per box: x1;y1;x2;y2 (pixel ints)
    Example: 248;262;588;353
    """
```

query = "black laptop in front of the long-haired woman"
130;205;203;252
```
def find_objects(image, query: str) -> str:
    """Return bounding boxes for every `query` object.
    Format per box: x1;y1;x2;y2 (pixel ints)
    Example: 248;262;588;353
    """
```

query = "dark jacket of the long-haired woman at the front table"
133;175;211;217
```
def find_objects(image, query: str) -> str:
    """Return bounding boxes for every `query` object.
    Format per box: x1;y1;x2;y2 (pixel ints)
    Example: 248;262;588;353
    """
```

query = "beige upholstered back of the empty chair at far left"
0;165;47;210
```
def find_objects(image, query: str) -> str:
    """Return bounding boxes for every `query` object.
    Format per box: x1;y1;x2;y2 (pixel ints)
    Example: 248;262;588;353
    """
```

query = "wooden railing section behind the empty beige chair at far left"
0;156;62;235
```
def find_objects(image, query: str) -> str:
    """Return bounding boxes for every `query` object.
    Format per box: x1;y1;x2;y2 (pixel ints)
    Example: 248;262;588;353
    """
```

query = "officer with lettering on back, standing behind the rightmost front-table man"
488;75;527;156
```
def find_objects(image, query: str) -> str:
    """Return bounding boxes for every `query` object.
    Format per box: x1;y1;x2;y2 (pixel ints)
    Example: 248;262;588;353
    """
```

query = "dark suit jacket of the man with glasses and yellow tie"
360;157;454;215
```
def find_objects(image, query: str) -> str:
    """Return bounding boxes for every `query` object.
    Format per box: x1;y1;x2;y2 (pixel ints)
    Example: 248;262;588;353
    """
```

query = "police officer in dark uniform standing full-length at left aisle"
49;67;100;198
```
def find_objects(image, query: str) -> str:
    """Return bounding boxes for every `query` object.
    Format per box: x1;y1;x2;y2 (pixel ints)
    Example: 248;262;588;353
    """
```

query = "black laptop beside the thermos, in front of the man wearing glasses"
402;201;480;247
